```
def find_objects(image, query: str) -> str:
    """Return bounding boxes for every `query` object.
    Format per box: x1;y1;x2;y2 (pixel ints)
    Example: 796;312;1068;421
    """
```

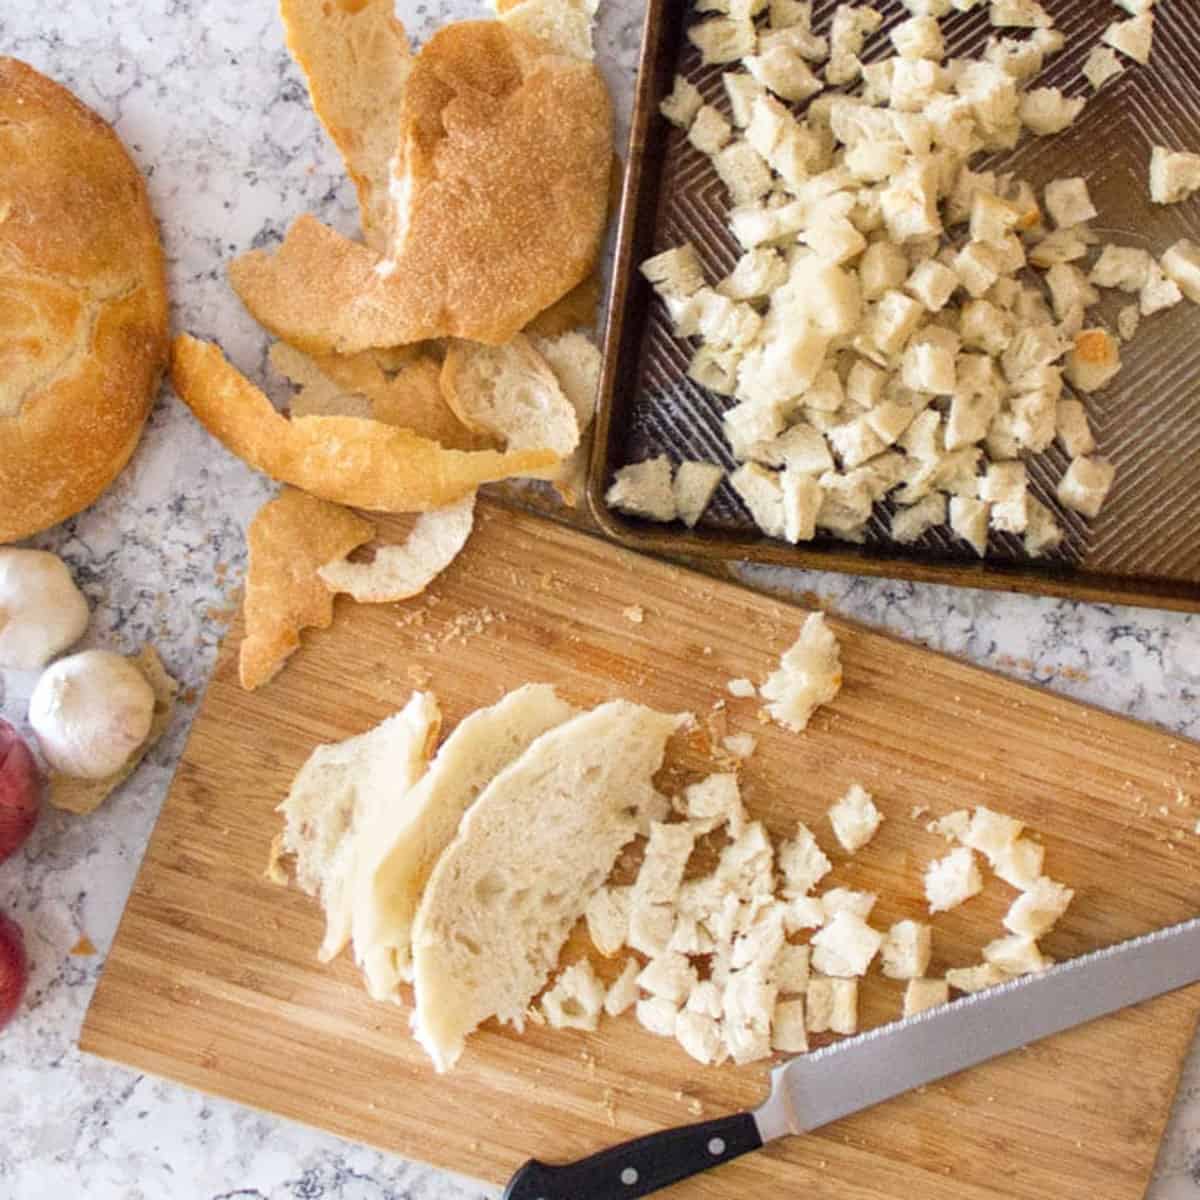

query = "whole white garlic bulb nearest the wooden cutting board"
29;650;154;779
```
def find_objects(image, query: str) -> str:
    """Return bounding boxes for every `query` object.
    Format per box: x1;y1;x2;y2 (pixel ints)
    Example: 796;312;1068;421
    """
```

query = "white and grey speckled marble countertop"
0;0;1200;1200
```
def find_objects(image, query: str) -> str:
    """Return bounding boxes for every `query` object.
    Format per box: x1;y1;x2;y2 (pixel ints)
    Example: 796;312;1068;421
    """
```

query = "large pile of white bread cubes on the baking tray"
607;0;1200;557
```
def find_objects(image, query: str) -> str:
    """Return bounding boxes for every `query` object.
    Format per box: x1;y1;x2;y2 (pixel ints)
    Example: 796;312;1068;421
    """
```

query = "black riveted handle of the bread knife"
504;1112;762;1200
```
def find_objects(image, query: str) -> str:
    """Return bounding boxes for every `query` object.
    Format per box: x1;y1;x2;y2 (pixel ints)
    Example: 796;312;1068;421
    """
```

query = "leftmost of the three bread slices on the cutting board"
278;691;442;962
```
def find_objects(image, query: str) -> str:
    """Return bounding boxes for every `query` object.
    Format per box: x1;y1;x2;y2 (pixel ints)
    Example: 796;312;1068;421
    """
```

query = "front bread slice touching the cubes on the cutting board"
413;700;686;1072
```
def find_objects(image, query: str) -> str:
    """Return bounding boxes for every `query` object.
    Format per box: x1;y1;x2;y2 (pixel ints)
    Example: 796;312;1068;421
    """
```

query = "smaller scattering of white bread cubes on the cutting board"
540;617;1074;1064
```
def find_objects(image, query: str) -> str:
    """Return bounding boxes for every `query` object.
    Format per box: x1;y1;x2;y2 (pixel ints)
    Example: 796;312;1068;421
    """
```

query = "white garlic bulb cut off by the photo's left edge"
0;548;88;671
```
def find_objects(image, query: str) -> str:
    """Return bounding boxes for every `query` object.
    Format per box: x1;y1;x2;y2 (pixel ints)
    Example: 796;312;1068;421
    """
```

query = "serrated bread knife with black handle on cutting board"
504;919;1200;1200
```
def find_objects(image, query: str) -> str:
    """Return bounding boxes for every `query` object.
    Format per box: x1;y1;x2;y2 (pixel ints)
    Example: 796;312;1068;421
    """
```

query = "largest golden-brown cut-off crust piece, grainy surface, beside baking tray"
230;22;612;354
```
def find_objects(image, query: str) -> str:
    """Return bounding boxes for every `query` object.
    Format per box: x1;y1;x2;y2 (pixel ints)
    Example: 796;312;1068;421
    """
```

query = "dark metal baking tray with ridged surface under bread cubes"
589;0;1200;611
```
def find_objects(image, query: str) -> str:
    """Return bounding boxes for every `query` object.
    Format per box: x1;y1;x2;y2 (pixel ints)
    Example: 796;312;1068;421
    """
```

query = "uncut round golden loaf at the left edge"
0;58;168;542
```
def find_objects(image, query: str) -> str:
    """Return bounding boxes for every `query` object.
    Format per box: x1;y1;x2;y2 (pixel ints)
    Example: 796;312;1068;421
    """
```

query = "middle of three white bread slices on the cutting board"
354;684;577;1000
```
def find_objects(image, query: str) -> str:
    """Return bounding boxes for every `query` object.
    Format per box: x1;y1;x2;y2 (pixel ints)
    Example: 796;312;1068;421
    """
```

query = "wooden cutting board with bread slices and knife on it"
80;506;1200;1200
